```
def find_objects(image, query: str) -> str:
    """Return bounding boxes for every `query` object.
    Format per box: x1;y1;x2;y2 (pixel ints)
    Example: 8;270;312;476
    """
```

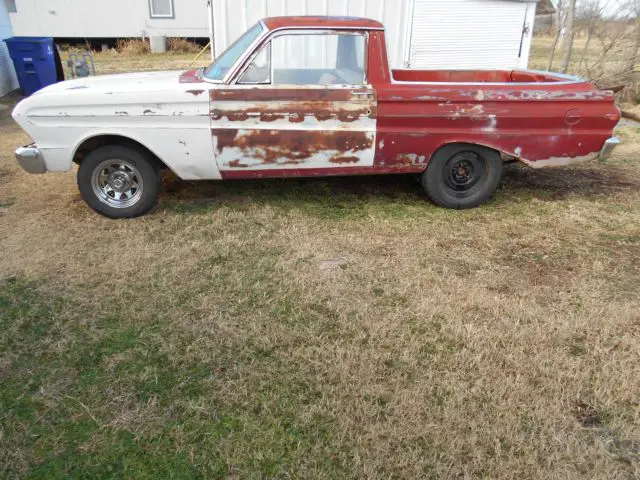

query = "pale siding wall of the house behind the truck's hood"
10;0;209;38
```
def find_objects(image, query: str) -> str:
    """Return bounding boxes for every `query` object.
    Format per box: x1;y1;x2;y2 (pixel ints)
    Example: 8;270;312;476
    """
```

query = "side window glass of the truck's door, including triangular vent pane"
239;32;366;85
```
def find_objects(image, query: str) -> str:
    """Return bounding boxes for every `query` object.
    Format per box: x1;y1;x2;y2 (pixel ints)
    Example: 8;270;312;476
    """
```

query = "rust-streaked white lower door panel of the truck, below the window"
210;86;377;173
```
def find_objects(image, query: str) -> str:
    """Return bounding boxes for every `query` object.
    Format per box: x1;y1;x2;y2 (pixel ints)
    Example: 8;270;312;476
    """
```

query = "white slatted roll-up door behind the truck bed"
407;0;535;69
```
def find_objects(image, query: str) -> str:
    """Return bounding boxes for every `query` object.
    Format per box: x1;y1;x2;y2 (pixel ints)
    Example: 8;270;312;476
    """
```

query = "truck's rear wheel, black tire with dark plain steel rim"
421;143;502;210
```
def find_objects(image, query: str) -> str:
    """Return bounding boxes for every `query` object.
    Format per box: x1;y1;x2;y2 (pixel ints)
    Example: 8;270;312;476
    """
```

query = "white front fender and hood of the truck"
13;71;220;180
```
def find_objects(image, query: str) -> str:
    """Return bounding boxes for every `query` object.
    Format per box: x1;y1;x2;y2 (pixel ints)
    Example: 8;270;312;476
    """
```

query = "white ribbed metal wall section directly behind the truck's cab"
213;0;409;67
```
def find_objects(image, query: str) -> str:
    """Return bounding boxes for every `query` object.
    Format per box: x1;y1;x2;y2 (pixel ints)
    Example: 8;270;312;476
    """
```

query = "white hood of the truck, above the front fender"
32;70;182;96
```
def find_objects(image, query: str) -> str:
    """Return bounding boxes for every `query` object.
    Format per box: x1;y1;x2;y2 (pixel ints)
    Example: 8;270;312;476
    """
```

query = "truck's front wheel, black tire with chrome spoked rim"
78;145;161;218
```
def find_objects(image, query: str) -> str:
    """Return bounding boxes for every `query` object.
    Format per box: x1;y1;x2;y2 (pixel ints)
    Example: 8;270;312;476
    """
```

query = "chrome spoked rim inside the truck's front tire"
91;160;143;208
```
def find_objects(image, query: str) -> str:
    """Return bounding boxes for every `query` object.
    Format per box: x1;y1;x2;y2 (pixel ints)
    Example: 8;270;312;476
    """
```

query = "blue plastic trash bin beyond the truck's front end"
5;37;64;96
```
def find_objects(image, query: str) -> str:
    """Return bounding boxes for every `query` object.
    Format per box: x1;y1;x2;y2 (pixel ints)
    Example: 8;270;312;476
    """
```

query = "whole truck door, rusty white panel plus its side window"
211;30;376;176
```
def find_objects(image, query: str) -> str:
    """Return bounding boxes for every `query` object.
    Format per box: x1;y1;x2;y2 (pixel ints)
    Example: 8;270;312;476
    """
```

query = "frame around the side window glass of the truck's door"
228;28;369;88
